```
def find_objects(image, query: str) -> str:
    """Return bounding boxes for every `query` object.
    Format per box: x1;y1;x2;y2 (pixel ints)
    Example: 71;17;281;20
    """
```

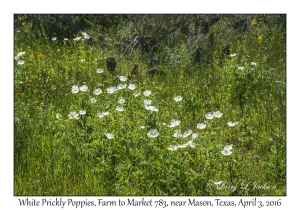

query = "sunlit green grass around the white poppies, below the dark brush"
14;15;286;196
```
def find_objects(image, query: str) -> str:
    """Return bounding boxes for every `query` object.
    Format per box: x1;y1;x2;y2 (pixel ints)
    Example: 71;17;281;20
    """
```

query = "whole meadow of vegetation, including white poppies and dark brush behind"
14;14;286;196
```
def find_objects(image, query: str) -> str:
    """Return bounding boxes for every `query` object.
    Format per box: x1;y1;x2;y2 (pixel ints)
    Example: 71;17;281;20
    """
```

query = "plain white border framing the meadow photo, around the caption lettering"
0;0;300;210
